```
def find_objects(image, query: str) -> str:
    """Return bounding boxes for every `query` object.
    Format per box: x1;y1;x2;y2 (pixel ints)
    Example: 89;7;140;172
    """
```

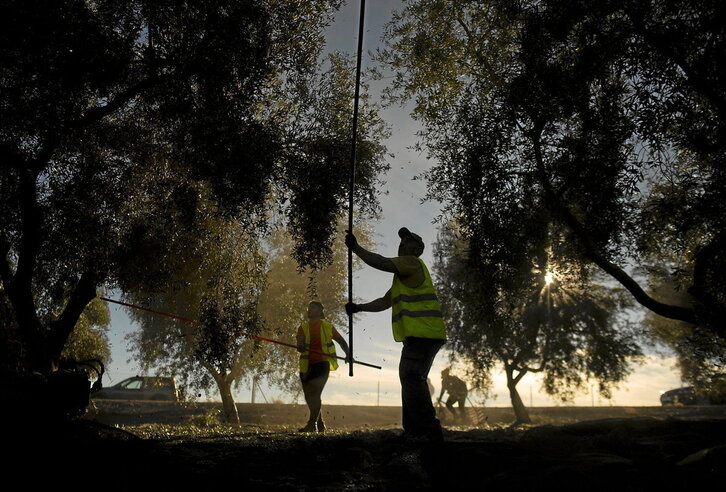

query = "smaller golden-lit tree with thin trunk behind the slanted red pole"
124;195;275;423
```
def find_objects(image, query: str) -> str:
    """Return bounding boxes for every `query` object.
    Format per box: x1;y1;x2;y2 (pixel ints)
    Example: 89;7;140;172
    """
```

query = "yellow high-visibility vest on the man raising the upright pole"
391;258;446;342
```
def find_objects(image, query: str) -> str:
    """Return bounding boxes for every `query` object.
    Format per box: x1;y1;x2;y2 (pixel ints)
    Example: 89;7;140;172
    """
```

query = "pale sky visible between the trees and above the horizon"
103;0;682;407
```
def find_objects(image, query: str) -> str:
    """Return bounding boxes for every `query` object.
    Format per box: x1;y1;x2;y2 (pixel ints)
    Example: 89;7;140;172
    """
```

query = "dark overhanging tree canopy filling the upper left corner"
0;0;385;372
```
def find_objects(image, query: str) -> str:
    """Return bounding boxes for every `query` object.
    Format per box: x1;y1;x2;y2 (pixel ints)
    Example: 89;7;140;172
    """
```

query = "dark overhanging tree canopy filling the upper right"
379;0;726;344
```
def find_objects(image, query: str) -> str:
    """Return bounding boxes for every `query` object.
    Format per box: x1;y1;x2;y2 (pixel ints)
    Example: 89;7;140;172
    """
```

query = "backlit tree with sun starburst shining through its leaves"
434;224;641;422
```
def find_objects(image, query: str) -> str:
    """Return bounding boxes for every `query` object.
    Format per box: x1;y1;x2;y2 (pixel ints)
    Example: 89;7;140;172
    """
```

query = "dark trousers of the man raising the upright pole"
398;337;444;436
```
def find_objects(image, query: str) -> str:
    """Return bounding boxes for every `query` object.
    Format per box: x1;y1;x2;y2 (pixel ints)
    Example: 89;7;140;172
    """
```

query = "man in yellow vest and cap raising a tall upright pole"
345;227;446;442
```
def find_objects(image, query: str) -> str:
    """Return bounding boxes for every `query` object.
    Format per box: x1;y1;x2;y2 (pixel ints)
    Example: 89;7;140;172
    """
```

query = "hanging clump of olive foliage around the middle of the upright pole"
280;52;389;268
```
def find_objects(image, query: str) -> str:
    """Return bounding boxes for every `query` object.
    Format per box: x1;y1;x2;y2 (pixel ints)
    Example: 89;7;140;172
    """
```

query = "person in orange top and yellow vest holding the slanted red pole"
297;301;348;432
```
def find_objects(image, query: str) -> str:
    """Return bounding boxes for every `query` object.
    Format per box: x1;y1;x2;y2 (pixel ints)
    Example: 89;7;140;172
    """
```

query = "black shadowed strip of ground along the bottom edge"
4;407;726;491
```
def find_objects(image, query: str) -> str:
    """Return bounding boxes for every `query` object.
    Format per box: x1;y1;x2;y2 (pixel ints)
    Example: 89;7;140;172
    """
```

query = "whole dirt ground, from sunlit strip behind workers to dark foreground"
4;402;726;491
